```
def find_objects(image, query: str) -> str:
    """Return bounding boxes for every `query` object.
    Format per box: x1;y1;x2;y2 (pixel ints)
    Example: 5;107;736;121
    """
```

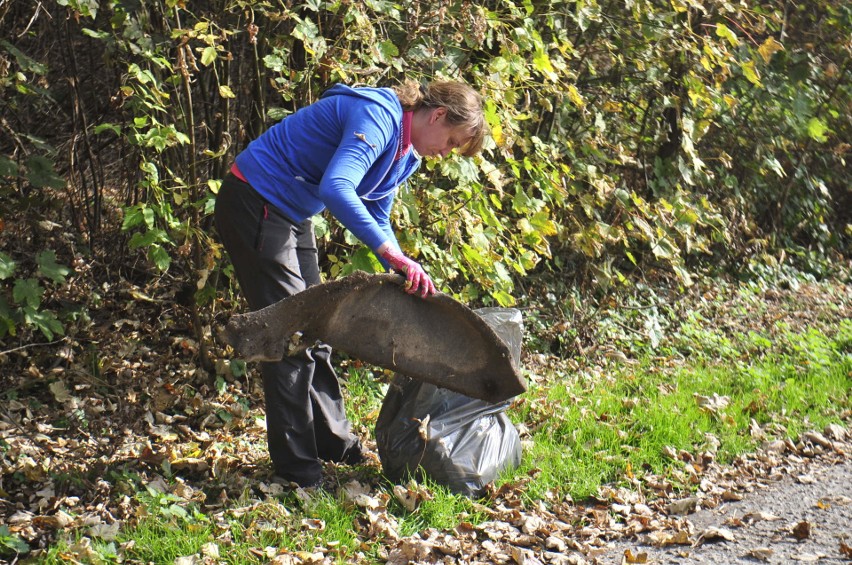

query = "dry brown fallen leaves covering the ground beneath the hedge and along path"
0;256;852;565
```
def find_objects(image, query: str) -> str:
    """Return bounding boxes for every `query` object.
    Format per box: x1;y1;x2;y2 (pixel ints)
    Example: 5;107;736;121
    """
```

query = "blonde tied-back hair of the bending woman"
393;80;486;157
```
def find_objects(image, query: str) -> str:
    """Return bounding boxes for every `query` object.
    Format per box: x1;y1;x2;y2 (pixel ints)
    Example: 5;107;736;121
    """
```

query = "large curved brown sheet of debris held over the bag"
222;272;526;403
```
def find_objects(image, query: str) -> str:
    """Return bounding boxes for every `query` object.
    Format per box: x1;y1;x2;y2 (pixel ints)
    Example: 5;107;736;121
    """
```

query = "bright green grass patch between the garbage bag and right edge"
512;321;852;498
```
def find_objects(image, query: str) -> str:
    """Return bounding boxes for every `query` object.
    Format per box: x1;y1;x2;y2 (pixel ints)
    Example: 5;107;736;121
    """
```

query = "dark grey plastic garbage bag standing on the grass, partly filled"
376;308;523;497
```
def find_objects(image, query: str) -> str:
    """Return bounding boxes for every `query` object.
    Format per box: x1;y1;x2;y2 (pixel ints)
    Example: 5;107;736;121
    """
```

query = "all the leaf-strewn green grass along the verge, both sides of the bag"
23;308;852;563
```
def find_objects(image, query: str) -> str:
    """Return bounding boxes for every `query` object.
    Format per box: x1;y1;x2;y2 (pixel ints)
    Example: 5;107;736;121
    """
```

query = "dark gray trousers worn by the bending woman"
215;174;358;486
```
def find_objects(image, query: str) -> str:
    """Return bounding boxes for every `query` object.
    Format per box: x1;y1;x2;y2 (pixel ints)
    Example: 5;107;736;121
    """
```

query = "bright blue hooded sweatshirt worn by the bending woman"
236;84;420;250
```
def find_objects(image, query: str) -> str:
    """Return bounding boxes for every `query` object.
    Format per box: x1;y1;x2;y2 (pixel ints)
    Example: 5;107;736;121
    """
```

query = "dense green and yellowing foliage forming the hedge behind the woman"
0;0;852;348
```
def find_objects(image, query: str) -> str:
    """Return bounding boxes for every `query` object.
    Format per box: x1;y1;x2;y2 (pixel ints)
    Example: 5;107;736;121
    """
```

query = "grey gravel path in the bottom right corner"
597;454;852;565
